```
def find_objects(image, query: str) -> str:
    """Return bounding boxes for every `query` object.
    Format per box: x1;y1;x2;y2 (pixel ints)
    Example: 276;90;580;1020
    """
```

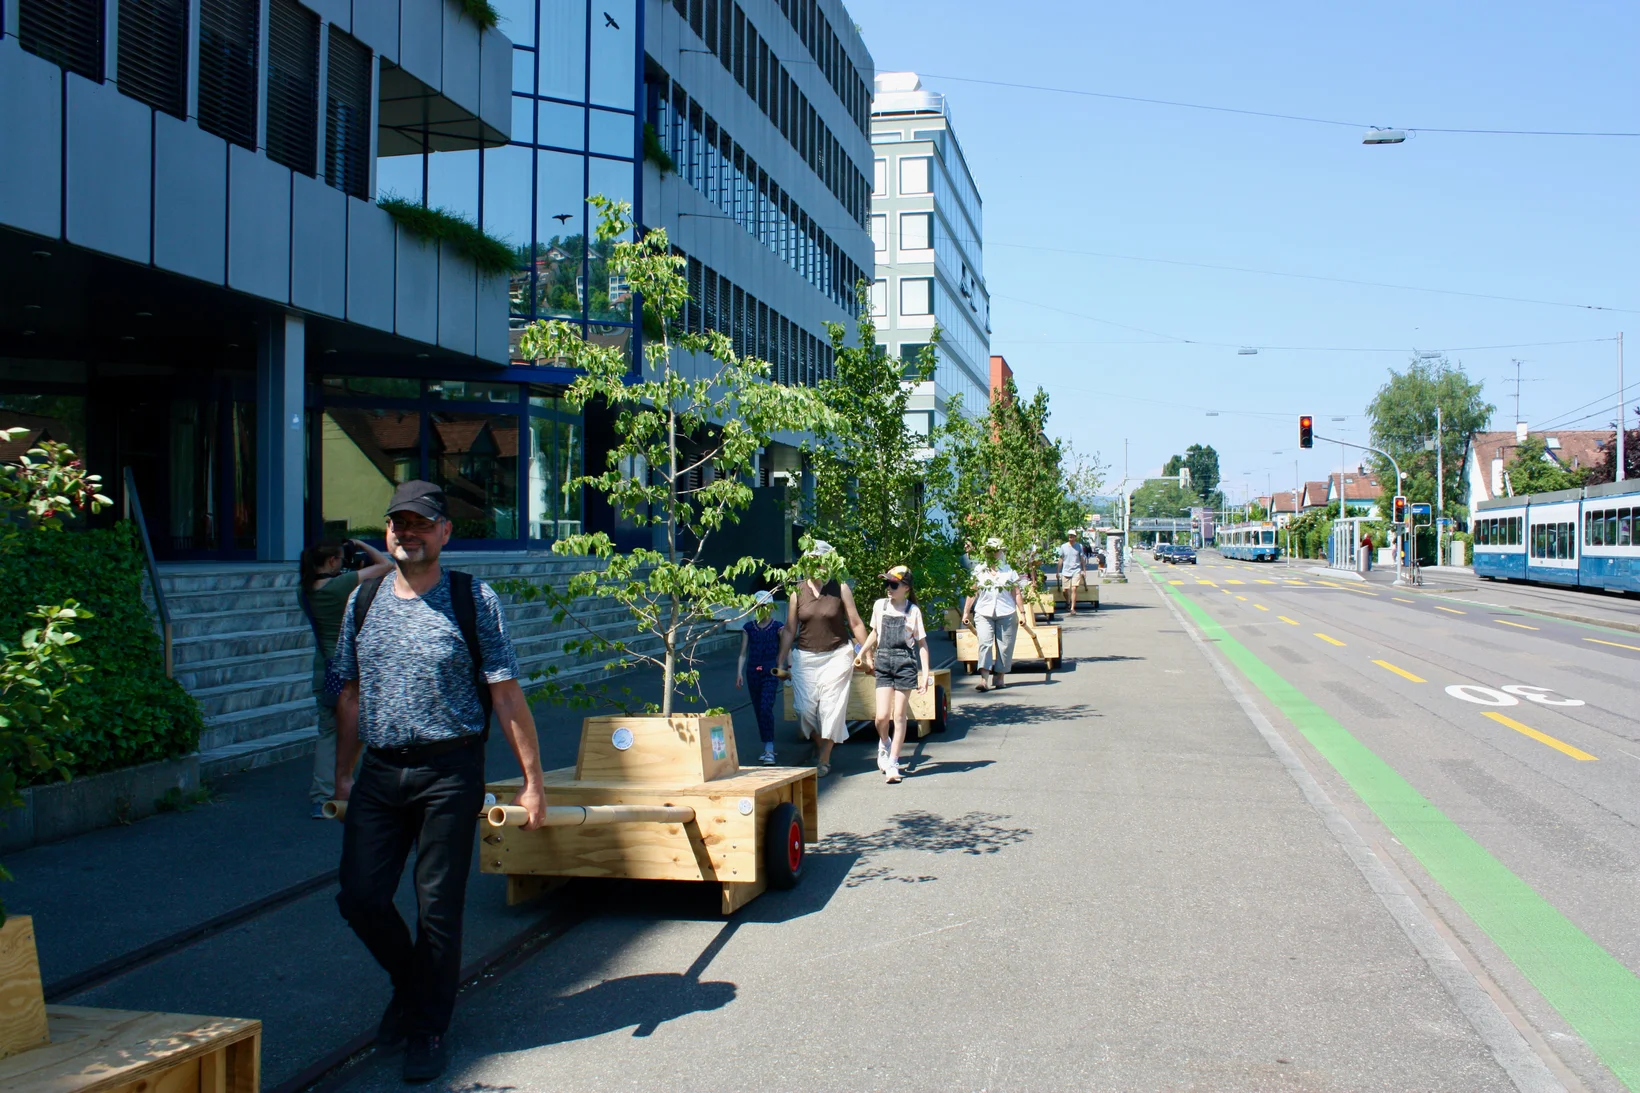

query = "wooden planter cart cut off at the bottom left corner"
0;916;262;1093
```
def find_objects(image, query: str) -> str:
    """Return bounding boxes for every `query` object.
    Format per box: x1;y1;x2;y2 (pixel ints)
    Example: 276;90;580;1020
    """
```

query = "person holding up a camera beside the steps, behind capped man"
297;538;394;819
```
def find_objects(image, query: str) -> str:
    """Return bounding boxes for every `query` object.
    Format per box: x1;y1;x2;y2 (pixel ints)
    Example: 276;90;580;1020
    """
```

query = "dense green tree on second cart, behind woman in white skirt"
809;306;968;619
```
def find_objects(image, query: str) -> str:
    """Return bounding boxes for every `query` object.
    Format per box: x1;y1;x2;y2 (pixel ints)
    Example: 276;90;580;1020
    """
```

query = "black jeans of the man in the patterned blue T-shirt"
336;740;484;1036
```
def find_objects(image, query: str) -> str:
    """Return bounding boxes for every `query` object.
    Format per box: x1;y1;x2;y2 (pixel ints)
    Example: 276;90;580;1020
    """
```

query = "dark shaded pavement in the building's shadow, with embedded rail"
5;617;950;1090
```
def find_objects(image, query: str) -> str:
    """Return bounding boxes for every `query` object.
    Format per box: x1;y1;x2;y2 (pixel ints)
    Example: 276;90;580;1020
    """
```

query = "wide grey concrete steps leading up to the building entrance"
161;553;738;778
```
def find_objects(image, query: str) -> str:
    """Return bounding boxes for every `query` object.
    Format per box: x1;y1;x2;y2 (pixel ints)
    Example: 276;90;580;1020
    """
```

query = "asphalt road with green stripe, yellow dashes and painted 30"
1148;551;1640;1090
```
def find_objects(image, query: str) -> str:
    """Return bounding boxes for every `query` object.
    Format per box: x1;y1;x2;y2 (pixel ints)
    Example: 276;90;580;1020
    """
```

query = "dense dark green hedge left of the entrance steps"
0;522;205;781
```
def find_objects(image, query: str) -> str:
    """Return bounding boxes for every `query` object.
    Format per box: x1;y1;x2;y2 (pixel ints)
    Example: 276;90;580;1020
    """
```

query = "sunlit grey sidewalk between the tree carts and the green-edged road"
323;576;1510;1091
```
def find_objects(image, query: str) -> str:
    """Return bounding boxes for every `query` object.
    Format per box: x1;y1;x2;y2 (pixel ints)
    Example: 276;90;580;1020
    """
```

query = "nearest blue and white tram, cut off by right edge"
1471;481;1640;592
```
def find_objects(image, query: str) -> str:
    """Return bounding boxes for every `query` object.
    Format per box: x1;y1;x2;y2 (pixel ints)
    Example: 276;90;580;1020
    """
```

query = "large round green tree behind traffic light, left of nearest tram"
1366;358;1496;505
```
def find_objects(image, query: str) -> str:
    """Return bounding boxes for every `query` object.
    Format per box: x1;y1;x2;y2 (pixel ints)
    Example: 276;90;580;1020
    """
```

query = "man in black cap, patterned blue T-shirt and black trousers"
336;481;546;1082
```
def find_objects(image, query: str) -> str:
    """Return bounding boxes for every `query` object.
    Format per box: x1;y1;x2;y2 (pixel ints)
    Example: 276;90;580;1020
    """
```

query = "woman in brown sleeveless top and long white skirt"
781;542;866;778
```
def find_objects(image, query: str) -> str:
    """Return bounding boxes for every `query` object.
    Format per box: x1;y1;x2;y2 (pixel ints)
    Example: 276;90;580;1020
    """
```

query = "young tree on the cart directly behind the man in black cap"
507;195;830;716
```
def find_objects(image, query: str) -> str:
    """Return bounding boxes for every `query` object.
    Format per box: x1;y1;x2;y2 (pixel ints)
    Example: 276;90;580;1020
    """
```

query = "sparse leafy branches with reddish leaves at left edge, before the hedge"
0;428;112;926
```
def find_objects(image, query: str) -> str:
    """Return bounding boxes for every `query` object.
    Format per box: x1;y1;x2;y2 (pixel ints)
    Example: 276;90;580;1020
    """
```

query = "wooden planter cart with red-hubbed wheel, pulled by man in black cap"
479;716;818;914
